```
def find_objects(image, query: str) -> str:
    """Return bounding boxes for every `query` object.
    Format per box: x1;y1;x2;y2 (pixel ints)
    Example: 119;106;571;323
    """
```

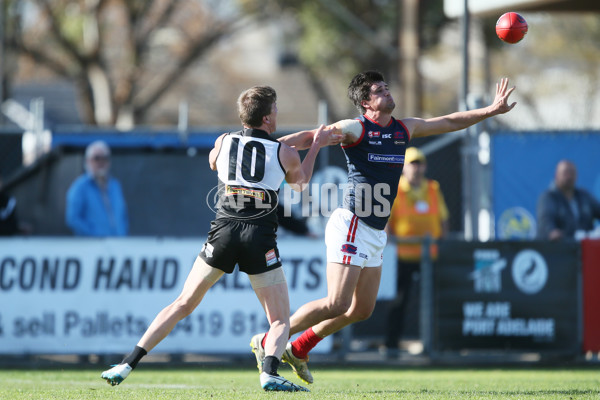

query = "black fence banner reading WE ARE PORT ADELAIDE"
432;241;580;354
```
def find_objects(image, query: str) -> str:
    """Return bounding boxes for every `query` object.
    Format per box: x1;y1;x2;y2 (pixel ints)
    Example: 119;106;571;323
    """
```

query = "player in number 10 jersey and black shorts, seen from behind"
101;86;339;392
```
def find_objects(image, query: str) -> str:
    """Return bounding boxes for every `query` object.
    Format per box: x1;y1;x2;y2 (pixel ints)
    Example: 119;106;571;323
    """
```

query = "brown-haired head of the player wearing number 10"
237;86;277;128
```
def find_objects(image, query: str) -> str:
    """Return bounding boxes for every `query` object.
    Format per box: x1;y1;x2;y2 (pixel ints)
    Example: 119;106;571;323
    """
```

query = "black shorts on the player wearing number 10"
200;219;281;275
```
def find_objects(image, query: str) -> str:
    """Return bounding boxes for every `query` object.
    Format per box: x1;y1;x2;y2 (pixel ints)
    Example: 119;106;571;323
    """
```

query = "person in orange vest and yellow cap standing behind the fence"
385;147;448;358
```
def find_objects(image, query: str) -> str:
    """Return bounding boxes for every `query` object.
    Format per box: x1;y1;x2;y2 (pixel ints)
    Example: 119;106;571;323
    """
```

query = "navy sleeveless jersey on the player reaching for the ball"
342;115;410;229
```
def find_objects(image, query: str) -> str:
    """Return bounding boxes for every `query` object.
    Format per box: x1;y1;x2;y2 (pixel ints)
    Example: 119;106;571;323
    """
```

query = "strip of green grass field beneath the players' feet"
0;365;600;400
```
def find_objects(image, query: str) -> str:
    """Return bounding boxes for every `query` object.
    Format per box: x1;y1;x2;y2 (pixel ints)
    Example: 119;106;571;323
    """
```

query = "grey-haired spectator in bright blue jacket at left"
66;141;129;236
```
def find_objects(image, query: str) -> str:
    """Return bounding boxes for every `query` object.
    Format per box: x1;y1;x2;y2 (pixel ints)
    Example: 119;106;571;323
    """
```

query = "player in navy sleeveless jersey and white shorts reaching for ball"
251;71;516;383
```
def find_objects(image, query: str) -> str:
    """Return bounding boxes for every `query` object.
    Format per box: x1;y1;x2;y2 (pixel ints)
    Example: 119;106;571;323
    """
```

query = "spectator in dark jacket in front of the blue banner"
537;160;600;240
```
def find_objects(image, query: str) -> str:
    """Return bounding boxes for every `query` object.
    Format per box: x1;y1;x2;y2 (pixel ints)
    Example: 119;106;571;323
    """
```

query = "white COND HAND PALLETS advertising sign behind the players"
0;238;396;354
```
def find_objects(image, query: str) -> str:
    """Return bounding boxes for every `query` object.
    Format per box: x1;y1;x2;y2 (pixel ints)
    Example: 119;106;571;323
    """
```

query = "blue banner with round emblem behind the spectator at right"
492;132;600;239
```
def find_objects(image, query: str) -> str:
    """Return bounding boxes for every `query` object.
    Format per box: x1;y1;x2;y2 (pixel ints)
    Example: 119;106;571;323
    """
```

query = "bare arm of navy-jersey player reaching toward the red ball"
402;78;517;138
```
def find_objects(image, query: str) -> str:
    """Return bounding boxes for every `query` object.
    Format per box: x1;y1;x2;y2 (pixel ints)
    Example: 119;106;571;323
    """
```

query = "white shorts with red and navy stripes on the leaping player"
325;208;387;268
